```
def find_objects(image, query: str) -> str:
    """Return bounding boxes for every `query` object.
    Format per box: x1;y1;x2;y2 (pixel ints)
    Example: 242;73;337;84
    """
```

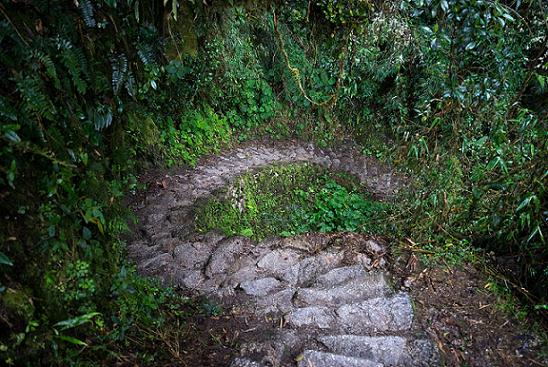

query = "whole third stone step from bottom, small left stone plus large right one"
284;293;413;334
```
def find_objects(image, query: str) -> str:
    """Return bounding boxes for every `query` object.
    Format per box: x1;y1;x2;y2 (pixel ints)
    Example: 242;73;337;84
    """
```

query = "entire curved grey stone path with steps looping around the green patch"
128;143;437;367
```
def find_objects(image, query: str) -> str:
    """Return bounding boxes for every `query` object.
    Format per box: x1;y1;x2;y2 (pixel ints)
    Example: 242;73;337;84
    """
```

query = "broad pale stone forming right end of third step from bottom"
336;293;413;333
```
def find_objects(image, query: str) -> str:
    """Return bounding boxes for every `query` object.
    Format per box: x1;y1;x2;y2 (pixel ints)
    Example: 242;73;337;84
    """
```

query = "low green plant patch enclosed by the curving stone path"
196;164;389;240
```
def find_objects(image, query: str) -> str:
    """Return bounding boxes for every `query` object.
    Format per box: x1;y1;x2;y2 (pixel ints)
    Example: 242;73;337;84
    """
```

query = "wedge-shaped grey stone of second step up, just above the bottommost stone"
318;335;407;366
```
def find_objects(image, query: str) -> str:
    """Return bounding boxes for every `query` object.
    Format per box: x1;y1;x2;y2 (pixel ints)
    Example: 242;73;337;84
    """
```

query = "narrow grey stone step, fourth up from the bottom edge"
294;273;390;307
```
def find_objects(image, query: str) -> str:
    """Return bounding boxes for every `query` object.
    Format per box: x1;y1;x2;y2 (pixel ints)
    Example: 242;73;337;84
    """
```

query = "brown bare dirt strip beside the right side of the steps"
392;252;548;367
